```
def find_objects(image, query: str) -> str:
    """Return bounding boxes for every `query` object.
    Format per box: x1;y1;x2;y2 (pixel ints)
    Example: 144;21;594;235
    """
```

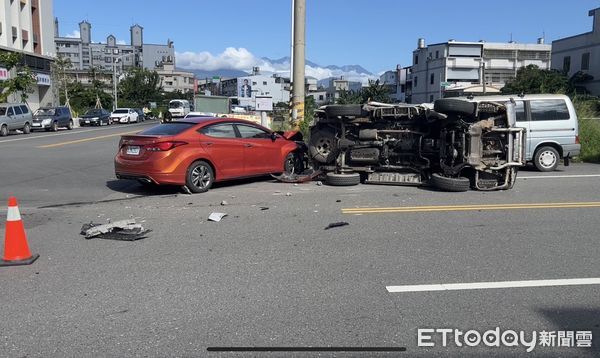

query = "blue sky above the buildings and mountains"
54;0;600;73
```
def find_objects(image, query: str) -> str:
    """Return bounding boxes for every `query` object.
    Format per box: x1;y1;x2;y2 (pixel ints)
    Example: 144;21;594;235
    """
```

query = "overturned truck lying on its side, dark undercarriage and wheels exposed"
308;99;525;191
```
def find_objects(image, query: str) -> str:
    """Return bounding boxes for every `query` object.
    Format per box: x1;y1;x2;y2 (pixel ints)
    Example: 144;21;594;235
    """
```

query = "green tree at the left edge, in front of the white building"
0;51;37;102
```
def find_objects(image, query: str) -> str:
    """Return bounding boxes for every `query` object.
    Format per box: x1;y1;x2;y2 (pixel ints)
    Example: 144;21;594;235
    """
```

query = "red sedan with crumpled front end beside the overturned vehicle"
115;118;301;193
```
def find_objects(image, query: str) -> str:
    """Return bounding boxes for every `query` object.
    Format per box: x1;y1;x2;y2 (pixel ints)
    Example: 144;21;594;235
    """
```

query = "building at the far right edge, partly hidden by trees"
552;8;600;95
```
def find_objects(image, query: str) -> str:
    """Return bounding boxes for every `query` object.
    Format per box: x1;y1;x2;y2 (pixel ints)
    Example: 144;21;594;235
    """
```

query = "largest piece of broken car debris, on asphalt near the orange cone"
81;219;152;241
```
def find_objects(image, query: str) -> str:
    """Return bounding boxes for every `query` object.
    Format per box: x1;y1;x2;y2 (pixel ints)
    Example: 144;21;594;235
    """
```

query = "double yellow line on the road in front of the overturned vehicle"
342;201;600;214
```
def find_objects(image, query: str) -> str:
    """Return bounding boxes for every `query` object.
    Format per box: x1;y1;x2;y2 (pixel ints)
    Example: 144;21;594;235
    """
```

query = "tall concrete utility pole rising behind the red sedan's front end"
292;0;306;129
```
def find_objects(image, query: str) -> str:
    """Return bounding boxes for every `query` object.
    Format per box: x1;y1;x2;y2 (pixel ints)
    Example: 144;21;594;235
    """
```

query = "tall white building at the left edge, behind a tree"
0;0;55;110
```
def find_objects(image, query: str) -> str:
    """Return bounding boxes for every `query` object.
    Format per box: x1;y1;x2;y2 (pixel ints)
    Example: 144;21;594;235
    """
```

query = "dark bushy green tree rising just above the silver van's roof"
502;65;574;94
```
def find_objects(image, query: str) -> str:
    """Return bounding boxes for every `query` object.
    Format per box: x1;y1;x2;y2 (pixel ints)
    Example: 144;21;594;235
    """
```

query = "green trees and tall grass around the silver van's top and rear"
502;65;600;163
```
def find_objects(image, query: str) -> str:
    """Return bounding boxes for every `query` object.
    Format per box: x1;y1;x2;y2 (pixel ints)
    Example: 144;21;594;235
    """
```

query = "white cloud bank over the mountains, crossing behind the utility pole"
175;47;374;84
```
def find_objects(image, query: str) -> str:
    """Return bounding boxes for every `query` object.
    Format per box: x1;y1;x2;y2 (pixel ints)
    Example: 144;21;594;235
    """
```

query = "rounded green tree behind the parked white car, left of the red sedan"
118;67;162;108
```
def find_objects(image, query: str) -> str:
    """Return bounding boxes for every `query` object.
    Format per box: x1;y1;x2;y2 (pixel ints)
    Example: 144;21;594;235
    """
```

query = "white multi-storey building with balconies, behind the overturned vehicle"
407;39;551;103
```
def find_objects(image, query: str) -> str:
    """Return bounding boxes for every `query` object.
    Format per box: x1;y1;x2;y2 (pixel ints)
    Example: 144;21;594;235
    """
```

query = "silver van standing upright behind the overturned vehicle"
468;94;581;172
